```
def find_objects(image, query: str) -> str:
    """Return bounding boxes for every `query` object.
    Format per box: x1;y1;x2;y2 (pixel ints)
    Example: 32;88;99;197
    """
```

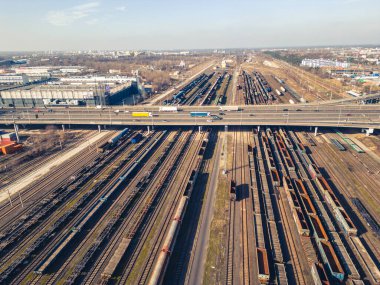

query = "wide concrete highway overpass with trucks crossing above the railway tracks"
0;104;380;129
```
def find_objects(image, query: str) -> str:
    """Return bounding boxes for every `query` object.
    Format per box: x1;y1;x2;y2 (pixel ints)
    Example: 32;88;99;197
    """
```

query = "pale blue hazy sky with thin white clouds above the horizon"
0;0;380;51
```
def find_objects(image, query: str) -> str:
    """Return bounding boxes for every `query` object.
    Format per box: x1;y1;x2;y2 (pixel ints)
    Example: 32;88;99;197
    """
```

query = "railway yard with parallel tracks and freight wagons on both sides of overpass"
0;60;380;285
